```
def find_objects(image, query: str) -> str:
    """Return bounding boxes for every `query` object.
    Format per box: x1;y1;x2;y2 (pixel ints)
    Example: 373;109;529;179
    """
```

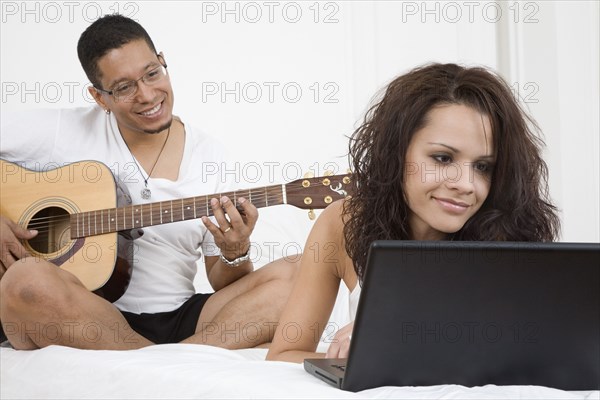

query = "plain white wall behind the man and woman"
0;1;600;261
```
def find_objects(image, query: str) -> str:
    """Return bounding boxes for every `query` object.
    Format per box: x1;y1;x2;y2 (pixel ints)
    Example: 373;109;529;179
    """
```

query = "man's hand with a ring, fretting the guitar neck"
202;196;258;260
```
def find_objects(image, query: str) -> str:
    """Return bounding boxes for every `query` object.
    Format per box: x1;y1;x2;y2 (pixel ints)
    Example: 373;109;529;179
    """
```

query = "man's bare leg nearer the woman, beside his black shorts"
182;256;299;349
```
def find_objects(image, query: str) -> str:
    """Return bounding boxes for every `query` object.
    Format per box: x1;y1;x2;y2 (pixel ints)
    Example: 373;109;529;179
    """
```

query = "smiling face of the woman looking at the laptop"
404;104;495;240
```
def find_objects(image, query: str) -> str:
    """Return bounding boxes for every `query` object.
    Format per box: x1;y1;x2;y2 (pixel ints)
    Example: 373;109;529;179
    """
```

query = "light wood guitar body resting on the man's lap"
0;160;130;301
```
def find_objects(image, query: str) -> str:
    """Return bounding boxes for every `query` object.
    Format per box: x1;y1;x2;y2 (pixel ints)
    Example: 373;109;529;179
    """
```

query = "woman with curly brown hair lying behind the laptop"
267;64;560;362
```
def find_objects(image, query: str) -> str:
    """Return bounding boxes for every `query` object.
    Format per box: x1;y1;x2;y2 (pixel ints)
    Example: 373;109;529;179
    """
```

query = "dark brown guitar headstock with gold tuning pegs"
285;173;352;210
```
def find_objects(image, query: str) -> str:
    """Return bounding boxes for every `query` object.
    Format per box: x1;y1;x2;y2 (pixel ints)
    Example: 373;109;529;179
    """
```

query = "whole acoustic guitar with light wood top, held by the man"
0;160;351;302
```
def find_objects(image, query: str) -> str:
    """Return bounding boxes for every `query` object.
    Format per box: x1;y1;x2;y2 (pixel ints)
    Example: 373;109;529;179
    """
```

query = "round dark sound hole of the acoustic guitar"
27;207;71;254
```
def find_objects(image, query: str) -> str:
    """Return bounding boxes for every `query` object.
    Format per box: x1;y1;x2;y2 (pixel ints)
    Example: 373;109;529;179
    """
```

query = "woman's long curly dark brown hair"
343;64;560;281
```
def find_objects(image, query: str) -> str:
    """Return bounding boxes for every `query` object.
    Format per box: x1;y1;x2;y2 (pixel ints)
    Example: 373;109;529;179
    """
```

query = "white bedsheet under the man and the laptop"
0;344;600;399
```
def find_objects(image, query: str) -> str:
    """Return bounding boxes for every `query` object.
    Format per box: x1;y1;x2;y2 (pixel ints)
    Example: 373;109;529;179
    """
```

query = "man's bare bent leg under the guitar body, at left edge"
0;258;152;350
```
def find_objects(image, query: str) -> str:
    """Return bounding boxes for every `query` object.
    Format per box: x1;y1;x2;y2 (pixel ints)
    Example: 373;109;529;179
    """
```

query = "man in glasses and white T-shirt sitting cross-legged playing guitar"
0;15;295;349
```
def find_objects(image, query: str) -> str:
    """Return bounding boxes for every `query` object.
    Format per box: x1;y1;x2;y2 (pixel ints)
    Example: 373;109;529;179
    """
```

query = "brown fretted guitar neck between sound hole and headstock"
70;184;287;239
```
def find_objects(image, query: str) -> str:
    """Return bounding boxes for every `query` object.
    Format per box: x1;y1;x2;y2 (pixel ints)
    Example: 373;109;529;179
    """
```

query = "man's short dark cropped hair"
77;14;156;89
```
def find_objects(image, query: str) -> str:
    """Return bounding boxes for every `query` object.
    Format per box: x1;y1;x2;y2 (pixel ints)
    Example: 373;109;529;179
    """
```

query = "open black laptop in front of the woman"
304;241;600;392
